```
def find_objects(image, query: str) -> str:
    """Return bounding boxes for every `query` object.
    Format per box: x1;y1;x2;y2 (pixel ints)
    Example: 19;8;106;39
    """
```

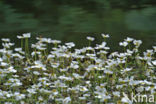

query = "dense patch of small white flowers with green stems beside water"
0;33;156;104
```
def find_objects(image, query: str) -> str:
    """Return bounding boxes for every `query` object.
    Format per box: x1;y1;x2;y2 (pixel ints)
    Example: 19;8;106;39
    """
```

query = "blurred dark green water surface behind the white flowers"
0;0;156;50
